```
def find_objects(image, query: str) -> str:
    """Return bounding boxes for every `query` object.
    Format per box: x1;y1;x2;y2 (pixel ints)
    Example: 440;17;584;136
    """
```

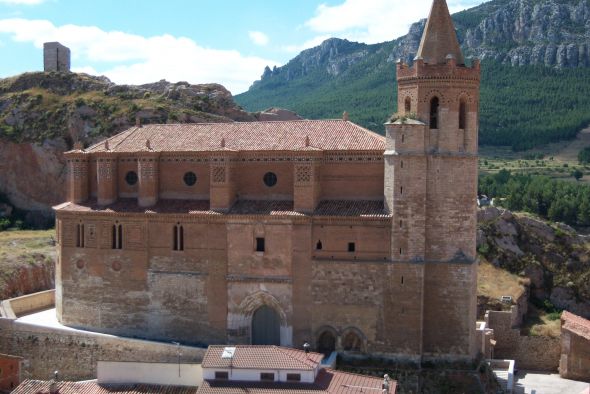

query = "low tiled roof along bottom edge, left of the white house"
11;379;197;394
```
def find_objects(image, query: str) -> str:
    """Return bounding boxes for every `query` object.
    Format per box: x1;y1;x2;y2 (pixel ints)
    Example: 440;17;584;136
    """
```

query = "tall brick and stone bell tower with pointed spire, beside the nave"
384;0;479;358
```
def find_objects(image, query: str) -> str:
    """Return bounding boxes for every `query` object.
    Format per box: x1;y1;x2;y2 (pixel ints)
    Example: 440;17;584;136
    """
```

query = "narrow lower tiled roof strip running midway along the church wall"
54;198;389;218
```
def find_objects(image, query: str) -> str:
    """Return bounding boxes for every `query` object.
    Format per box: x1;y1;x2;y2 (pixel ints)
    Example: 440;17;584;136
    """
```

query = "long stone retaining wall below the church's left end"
0;318;206;380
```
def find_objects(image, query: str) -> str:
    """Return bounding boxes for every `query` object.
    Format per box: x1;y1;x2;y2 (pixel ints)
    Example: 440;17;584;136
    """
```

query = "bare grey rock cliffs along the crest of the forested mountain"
261;0;590;81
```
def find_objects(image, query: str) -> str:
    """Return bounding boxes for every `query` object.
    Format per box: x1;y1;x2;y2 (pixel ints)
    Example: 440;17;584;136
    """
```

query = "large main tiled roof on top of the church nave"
86;120;385;152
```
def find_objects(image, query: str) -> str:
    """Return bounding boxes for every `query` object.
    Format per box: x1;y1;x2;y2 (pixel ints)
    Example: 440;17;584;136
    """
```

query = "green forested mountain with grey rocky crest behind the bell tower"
235;0;590;149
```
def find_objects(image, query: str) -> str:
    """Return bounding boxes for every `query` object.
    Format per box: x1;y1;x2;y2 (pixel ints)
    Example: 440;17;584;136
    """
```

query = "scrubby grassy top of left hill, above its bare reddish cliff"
0;72;254;146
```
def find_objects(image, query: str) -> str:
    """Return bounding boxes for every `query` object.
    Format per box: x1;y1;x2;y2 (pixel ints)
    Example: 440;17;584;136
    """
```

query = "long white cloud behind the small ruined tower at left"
0;18;279;94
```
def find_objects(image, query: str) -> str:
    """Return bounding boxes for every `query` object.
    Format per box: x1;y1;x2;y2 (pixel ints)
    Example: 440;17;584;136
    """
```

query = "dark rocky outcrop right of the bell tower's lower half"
477;207;590;317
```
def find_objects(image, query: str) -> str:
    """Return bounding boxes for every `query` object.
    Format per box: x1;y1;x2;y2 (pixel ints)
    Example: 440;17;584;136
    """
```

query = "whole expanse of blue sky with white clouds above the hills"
0;0;482;94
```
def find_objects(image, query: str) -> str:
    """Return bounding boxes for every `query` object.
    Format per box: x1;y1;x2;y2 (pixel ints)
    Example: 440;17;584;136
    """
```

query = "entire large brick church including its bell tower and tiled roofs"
55;0;480;361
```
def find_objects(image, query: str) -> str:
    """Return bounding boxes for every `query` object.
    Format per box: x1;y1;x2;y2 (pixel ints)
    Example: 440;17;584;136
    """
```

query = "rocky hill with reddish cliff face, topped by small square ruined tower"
0;73;286;217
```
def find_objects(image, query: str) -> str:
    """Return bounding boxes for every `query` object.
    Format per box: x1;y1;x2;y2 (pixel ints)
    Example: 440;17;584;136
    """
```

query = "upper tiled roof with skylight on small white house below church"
202;345;324;370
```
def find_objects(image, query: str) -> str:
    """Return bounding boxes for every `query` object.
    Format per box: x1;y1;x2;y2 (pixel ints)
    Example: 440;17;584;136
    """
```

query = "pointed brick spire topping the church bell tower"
416;0;465;64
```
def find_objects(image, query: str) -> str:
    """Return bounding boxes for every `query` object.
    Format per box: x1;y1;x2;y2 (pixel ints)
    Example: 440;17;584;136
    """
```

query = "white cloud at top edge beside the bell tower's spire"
305;0;483;44
